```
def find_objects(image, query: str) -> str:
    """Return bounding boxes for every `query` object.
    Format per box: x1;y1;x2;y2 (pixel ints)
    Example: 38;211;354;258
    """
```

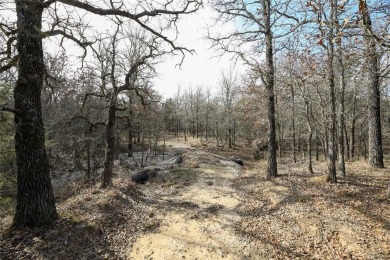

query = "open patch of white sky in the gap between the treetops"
155;3;244;98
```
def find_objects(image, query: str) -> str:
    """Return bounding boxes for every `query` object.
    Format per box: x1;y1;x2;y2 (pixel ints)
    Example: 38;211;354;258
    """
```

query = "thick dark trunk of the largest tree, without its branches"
13;1;58;227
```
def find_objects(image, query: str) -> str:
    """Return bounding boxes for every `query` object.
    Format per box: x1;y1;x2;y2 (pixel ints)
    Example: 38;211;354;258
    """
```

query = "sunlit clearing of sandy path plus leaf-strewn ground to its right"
130;140;390;259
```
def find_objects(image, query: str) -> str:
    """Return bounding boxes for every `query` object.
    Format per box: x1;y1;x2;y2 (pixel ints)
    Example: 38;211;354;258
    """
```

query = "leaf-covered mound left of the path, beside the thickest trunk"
0;181;159;259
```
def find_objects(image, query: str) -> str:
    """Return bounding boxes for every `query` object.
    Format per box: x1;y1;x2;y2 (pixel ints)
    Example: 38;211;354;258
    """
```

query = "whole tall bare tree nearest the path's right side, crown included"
208;0;306;178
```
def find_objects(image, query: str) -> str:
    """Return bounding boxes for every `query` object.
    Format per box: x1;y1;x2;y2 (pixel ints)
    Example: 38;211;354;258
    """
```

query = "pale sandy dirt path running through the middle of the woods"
130;152;245;260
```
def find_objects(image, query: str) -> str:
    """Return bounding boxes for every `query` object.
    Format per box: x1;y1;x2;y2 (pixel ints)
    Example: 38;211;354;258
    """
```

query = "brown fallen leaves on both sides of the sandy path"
0;145;390;259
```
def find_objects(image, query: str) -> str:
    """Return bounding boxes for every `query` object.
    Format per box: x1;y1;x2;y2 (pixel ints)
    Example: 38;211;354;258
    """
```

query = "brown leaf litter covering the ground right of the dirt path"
235;159;390;259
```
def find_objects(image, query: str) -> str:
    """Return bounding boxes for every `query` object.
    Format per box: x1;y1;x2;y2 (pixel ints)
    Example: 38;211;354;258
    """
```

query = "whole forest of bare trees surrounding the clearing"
0;0;390;234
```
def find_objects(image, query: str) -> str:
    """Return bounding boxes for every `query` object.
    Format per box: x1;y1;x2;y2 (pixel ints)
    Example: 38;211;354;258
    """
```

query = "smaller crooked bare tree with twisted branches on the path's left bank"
88;26;164;188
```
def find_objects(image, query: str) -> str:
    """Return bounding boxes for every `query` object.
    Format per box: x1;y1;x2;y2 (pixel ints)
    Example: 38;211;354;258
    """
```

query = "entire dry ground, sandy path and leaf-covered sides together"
0;138;390;260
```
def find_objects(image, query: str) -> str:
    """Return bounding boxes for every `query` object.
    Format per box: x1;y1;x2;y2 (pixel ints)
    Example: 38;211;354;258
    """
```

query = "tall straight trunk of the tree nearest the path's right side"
262;0;278;179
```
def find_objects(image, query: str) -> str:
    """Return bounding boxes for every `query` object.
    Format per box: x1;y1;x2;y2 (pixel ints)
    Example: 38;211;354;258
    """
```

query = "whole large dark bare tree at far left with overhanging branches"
1;0;201;227
